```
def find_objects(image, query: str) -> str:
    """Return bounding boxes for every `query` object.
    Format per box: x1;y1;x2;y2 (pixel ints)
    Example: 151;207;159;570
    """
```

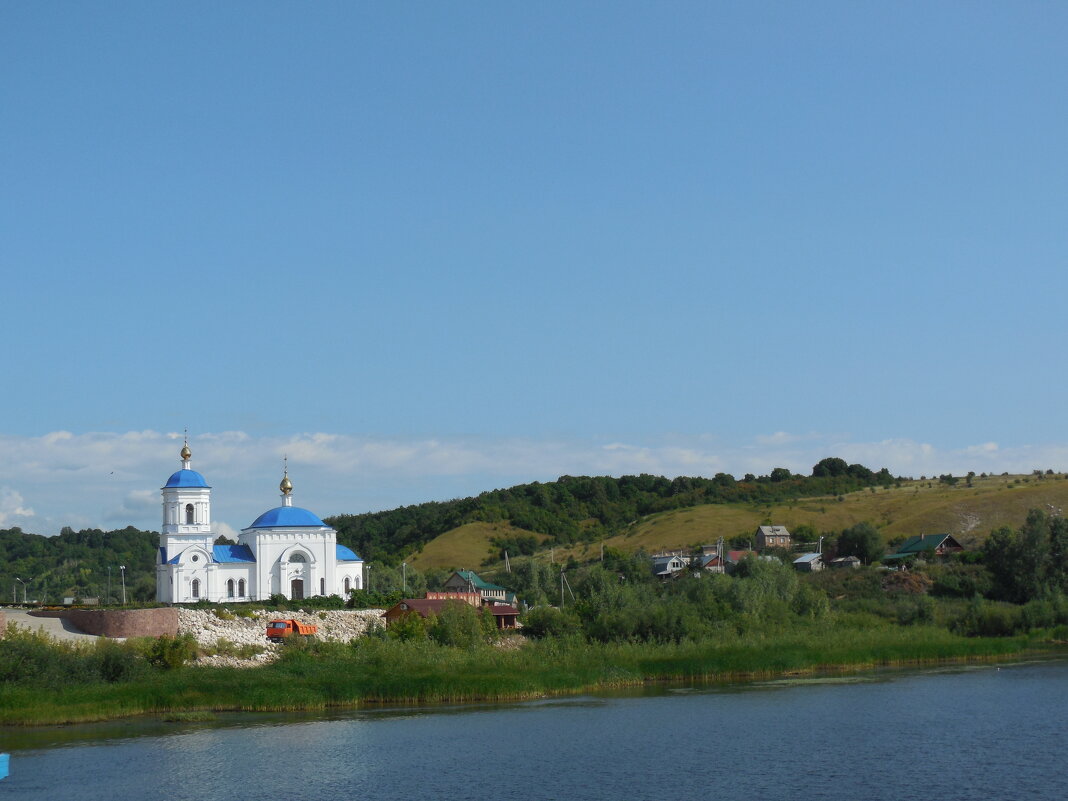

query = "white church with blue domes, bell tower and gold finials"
156;441;363;603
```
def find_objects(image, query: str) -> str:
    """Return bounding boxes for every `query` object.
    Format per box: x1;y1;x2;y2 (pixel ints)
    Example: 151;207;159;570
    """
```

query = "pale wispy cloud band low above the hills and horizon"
0;431;1068;536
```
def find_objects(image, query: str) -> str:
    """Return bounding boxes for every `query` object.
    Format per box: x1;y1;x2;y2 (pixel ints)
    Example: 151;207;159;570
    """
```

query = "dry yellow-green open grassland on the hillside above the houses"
412;475;1068;569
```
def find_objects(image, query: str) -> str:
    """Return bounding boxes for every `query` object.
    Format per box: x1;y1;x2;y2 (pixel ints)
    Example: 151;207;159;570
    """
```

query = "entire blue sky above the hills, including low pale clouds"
0;2;1068;533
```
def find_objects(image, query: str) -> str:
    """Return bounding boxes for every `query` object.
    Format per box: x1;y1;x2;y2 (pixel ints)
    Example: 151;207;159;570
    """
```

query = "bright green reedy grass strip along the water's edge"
0;625;1048;725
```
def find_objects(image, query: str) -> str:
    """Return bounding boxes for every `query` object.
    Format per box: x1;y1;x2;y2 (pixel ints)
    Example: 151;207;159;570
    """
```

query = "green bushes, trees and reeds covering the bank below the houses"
6;501;1068;725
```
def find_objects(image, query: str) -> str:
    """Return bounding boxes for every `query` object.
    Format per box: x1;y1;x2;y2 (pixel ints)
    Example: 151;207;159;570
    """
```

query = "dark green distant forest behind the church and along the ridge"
0;458;897;603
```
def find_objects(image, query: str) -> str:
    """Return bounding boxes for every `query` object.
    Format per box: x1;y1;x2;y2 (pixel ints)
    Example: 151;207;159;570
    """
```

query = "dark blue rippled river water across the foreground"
0;661;1068;801
